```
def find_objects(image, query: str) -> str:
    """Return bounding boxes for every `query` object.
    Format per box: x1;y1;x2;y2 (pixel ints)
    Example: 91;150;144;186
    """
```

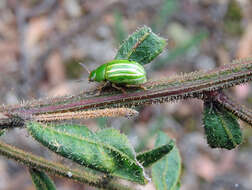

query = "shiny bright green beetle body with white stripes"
89;60;147;85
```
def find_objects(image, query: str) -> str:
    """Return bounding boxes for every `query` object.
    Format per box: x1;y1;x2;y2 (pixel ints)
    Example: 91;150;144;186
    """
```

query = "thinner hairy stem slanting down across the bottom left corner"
0;142;135;190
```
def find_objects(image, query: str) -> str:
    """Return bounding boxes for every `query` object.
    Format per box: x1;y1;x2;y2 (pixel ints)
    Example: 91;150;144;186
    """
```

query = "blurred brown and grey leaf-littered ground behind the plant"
0;0;252;190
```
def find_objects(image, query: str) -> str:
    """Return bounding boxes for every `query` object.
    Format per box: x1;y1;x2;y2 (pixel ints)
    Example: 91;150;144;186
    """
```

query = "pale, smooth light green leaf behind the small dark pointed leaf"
151;131;181;190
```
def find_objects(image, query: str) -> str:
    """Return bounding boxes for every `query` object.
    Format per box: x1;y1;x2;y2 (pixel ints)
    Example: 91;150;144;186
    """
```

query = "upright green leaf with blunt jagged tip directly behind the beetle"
115;26;166;65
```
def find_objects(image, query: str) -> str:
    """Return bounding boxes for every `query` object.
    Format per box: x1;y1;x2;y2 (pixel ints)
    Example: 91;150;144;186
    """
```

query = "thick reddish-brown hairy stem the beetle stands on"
0;58;252;128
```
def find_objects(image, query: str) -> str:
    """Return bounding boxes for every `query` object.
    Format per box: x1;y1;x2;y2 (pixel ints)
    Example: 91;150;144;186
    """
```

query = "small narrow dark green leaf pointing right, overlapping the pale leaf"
137;140;174;168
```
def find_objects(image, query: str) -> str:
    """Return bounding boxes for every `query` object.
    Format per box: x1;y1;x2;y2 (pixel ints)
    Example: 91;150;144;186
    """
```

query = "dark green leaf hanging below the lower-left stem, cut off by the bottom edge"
29;168;56;190
